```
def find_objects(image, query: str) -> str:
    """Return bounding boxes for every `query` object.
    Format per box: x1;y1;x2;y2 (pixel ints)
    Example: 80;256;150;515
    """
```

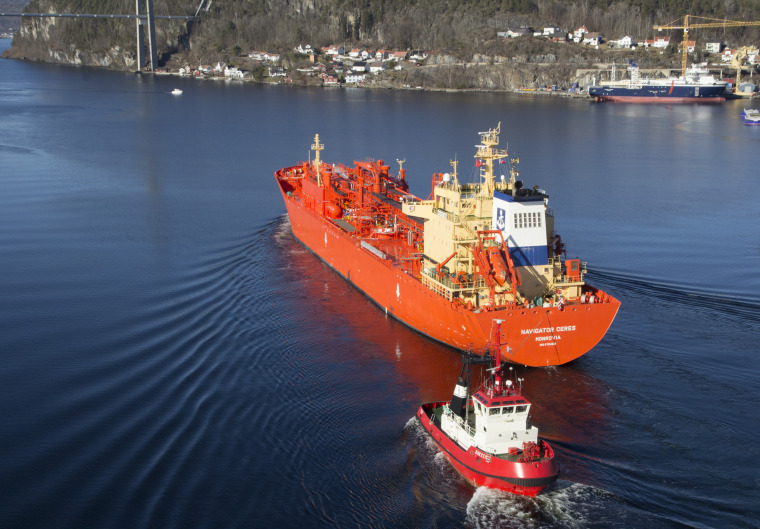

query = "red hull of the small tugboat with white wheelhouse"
417;402;559;497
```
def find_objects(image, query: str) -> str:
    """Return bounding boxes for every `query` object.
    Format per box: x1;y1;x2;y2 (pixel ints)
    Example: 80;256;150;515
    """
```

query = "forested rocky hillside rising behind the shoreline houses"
2;0;760;75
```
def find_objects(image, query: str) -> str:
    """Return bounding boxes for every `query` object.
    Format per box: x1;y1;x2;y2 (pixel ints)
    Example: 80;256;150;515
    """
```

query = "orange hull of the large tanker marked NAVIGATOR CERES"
278;180;620;367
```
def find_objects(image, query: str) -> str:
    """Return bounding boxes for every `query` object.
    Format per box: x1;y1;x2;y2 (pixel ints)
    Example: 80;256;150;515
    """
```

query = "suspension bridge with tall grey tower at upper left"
0;0;211;72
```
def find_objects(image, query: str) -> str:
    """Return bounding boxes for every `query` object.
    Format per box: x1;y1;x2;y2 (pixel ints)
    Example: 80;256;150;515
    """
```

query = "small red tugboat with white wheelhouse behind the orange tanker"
417;322;559;496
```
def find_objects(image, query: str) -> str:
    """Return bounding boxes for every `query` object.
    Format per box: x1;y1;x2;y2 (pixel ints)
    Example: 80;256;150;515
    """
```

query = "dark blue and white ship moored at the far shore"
588;63;729;103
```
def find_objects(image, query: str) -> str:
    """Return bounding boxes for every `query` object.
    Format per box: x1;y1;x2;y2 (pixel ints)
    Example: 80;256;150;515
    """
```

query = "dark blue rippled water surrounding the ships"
0;41;760;529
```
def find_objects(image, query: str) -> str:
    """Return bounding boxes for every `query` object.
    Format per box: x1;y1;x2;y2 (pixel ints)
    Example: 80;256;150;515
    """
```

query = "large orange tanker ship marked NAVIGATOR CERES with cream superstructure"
275;125;620;366
